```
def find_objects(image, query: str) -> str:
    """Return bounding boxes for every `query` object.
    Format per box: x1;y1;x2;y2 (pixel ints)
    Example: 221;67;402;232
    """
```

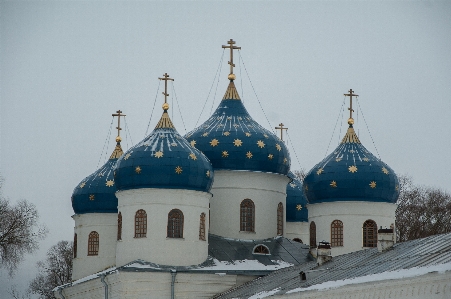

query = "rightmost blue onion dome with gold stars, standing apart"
304;126;399;204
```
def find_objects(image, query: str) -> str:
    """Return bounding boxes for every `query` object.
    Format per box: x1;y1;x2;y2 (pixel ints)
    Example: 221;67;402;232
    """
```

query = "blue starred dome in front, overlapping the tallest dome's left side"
115;110;213;192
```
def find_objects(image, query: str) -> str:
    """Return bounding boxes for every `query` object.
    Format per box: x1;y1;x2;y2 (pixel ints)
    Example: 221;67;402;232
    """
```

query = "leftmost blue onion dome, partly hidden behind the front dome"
72;136;123;214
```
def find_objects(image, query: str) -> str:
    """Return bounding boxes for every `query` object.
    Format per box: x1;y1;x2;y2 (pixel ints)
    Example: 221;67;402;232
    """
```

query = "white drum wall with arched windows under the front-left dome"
116;189;211;266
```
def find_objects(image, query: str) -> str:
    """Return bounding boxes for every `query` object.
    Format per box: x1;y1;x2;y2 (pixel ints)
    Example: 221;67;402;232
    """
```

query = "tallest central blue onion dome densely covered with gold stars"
185;81;290;175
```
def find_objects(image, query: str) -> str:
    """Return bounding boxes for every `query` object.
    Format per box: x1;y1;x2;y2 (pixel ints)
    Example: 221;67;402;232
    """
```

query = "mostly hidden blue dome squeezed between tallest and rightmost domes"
286;171;308;222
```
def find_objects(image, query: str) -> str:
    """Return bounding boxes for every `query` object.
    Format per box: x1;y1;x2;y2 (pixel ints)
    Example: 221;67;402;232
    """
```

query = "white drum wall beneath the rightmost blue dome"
308;201;396;256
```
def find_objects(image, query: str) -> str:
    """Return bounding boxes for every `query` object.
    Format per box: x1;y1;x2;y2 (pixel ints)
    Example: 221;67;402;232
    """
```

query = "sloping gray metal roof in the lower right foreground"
214;234;451;298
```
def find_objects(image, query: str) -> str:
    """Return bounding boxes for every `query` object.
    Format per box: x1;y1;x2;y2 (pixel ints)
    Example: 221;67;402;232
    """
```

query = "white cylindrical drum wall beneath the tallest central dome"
210;170;289;239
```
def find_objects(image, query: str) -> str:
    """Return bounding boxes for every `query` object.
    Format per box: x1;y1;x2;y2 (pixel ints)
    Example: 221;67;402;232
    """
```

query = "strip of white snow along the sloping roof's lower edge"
288;262;451;298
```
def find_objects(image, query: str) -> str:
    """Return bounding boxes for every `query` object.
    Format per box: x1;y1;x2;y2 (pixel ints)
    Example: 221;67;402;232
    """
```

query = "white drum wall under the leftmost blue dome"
72;213;117;280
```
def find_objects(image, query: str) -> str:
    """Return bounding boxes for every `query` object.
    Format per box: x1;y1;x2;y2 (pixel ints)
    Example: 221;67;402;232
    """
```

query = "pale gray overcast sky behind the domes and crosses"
0;1;451;298
